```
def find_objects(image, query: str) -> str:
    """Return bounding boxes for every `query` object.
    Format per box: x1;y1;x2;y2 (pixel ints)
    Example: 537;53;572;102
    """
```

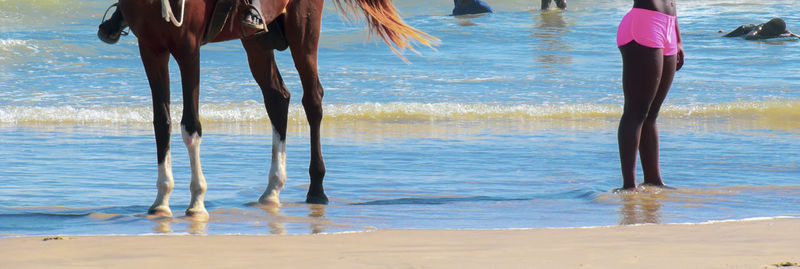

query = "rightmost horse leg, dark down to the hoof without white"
286;0;328;204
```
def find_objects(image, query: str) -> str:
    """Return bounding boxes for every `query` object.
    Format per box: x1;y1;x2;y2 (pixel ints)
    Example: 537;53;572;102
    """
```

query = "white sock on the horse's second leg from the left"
181;125;208;218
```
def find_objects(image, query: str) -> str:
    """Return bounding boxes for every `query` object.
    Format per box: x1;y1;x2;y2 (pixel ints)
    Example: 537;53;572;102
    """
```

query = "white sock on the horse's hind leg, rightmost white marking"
258;126;286;205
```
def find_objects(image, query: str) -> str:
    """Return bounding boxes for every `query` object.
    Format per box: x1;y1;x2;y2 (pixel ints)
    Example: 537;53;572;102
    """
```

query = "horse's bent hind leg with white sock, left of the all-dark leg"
242;39;290;205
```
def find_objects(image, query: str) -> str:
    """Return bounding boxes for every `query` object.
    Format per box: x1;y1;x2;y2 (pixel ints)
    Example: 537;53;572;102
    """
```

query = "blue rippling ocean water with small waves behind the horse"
0;0;800;233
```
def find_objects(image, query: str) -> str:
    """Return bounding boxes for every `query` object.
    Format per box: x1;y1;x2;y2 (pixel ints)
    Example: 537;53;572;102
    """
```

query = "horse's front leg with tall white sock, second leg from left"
175;46;208;220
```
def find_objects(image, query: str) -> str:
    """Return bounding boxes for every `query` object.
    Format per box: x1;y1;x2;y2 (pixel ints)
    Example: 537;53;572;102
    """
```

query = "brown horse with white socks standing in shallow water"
118;0;438;219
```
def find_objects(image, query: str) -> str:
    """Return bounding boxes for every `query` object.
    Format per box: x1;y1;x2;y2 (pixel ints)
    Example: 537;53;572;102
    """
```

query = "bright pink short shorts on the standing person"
617;8;678;56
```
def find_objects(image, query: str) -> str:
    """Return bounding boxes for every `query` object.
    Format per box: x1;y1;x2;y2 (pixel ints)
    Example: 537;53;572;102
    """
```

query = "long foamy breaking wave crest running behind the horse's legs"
0;100;800;124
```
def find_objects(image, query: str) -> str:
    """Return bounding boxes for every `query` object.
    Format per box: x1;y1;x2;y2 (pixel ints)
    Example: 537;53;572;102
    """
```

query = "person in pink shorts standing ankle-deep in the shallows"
617;0;683;189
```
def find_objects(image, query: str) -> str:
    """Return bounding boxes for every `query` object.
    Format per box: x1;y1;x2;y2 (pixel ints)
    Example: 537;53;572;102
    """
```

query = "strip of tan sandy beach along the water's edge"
0;219;800;268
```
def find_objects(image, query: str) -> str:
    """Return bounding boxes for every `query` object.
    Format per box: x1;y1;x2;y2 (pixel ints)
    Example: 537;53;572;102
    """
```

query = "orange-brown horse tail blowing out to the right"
334;0;440;61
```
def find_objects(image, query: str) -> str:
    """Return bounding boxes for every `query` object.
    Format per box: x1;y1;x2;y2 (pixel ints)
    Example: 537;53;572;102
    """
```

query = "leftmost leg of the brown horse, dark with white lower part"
139;43;175;216
